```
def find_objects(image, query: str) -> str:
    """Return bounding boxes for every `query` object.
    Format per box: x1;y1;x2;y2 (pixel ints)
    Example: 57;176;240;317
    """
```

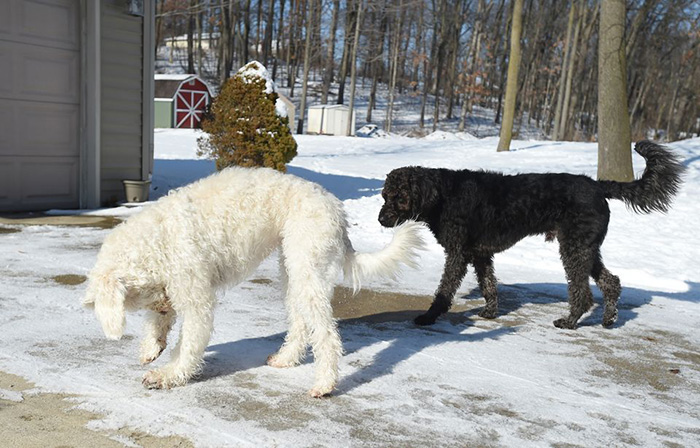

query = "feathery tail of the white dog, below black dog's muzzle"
343;221;425;292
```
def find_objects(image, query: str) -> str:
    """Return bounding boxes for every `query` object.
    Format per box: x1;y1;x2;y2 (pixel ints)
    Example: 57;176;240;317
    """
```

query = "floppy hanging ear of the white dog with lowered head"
83;273;126;339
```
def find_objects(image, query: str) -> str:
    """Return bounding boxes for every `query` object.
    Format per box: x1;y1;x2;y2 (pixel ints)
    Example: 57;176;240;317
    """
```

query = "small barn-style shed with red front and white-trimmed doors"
155;75;211;128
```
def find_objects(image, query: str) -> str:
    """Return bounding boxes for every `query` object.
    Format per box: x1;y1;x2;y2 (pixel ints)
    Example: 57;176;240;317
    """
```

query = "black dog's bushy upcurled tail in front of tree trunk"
600;140;685;213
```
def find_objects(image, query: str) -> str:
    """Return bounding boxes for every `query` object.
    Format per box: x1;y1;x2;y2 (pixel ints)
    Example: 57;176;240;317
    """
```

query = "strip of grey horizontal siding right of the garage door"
101;0;143;204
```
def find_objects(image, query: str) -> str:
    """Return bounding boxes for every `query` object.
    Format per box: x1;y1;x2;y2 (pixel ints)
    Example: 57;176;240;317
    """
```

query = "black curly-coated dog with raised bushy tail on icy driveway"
379;141;684;328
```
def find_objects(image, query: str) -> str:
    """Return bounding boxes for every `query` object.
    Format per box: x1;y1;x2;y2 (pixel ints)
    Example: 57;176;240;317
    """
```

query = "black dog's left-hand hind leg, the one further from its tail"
554;239;594;330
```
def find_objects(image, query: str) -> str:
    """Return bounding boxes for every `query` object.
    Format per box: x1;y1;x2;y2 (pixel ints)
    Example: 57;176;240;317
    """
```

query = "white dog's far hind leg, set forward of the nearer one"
267;251;308;367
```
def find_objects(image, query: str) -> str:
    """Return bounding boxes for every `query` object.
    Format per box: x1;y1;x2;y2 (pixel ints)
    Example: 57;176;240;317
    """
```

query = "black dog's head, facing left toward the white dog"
379;166;439;227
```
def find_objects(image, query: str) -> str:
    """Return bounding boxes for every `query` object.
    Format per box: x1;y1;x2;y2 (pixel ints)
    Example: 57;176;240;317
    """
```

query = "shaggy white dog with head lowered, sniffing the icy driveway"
84;168;423;397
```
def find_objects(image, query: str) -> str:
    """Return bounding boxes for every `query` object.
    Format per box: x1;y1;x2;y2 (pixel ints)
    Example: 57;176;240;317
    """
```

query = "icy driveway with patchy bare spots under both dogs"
0;221;700;447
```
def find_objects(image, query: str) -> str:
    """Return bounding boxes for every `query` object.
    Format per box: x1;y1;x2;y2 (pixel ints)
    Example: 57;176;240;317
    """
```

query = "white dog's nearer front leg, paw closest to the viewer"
143;303;214;389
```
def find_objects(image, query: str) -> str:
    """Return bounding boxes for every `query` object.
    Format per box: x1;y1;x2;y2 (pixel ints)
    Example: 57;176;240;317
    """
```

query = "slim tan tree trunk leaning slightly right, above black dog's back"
497;0;523;151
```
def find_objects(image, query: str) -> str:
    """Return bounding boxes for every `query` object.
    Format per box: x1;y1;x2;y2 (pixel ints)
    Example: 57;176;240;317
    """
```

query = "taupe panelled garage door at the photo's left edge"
0;0;80;211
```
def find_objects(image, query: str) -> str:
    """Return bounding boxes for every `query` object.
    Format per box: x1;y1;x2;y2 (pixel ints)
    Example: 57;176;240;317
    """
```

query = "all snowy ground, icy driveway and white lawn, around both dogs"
0;130;700;447
